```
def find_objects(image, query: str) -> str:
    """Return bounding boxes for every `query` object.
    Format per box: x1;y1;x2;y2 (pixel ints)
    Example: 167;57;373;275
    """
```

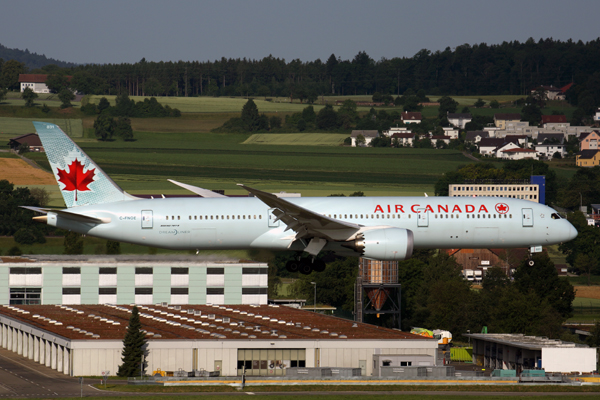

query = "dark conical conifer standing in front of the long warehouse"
117;306;147;377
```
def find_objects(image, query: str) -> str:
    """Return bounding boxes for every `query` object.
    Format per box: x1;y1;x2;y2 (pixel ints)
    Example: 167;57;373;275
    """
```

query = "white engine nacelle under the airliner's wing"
352;228;414;261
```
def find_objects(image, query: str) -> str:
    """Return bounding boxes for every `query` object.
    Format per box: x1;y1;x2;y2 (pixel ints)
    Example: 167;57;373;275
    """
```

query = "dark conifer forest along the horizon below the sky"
0;38;600;104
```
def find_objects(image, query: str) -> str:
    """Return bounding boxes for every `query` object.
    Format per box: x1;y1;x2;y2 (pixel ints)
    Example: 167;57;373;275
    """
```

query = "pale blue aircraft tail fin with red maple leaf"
33;122;136;208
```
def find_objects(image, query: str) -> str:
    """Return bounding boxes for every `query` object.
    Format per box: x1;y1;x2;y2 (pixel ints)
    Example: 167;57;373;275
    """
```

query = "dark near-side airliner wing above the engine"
238;184;361;242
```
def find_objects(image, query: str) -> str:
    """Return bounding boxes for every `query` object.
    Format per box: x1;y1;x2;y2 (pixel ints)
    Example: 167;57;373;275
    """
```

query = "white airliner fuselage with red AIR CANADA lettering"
48;197;577;255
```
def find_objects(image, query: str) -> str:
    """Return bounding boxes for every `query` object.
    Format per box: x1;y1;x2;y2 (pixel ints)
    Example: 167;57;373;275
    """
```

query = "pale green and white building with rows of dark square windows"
0;256;268;305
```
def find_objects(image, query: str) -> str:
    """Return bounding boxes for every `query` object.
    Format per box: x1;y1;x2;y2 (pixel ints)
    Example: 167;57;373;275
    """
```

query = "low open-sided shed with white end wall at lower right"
465;333;597;373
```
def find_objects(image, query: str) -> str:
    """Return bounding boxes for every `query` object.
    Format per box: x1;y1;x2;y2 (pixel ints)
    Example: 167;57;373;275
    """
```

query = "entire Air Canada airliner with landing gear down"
25;122;577;273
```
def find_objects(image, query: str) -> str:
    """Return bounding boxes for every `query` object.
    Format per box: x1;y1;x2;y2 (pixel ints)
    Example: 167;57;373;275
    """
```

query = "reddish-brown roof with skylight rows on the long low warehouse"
0;303;423;340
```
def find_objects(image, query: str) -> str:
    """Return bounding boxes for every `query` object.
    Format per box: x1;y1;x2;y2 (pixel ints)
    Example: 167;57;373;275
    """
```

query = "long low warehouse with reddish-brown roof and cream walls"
0;304;438;376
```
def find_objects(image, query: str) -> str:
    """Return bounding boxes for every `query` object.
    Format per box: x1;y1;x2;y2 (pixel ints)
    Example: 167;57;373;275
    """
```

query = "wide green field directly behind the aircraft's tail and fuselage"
23;132;472;196
